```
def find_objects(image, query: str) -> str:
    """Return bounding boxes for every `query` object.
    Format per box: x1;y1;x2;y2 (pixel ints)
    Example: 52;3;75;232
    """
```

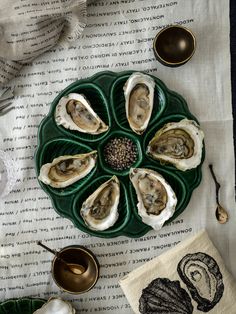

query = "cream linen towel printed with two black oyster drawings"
119;231;236;314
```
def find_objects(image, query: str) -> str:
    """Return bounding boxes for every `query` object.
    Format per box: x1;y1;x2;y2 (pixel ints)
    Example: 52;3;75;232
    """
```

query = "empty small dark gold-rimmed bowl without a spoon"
153;25;196;67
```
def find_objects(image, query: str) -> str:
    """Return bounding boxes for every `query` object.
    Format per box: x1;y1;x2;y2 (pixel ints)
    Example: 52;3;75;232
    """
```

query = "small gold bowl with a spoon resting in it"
52;245;99;294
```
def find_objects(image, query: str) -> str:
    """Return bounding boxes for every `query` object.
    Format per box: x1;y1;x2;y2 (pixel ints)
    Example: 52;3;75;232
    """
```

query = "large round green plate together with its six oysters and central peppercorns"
35;71;205;238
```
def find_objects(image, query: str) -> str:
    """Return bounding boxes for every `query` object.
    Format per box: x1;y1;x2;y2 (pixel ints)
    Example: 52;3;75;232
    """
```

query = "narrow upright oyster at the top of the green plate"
124;72;155;134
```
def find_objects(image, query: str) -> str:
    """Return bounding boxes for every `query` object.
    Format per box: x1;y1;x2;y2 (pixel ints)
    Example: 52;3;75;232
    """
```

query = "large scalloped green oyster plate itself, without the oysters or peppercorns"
35;71;205;238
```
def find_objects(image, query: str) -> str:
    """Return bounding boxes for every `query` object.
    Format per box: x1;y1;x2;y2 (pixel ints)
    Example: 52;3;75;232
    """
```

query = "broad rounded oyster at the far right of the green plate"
147;119;204;171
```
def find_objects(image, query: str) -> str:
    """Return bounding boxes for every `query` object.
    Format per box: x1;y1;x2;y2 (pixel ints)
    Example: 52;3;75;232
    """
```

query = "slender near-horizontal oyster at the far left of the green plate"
38;150;97;188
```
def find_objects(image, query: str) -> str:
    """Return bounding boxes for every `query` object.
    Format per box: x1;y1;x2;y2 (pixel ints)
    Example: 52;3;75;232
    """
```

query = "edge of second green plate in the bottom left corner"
0;298;46;314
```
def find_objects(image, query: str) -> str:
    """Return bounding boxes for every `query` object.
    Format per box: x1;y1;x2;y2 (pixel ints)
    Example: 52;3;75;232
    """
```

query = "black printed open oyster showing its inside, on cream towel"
177;252;224;312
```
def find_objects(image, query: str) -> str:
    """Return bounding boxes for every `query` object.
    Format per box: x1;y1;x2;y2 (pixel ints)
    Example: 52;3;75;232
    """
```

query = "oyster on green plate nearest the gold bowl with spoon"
80;176;120;230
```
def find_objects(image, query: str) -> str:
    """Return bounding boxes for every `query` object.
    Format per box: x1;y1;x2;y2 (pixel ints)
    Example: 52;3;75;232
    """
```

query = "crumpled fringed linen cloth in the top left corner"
0;0;86;86
